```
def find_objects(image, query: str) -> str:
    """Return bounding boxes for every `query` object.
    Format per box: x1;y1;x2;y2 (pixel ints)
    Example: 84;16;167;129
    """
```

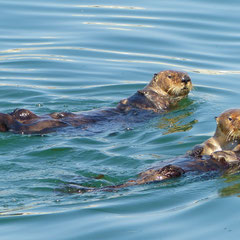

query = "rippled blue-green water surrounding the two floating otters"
0;0;240;240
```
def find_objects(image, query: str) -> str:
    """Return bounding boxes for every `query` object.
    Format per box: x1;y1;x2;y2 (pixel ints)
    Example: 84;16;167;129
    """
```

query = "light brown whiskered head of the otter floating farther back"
149;70;192;97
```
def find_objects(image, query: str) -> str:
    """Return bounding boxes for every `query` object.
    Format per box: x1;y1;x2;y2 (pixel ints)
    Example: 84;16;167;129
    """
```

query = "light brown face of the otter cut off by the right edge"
216;109;240;142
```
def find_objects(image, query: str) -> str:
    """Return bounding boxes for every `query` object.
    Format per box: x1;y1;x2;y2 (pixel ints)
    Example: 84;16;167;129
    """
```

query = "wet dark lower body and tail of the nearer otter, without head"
69;154;240;193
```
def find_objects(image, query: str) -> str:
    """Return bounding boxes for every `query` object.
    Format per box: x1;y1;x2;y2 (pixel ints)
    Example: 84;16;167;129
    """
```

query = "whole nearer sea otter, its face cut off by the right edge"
69;109;240;192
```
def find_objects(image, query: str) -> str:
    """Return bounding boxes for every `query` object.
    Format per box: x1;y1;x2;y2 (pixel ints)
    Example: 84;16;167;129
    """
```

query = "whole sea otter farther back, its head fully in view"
0;70;192;134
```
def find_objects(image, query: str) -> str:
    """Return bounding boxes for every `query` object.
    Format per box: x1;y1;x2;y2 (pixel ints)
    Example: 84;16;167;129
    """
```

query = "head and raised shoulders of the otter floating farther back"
118;70;192;112
